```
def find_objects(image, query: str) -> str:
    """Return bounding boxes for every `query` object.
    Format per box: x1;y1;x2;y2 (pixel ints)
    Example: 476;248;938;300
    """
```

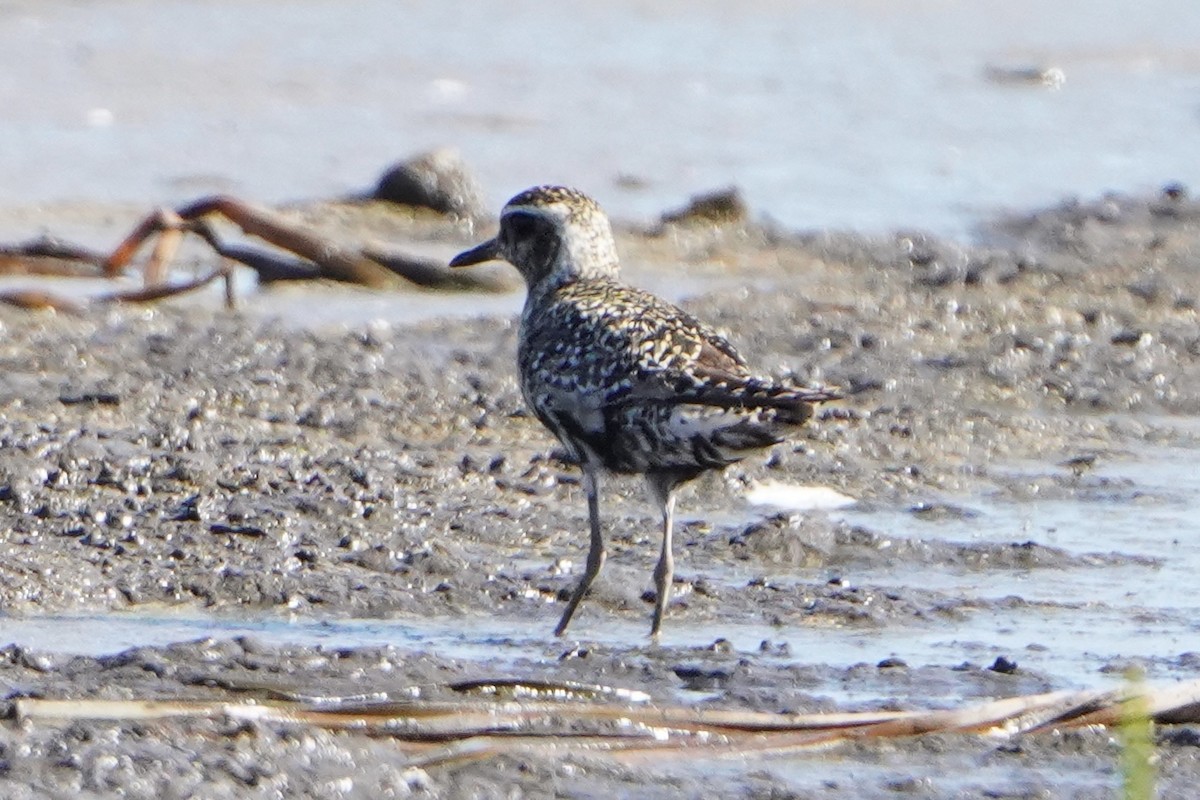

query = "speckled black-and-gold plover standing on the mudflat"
450;186;839;640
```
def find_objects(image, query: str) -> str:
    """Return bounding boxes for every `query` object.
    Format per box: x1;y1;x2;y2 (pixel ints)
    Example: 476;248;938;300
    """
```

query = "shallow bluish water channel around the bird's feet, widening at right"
0;434;1200;702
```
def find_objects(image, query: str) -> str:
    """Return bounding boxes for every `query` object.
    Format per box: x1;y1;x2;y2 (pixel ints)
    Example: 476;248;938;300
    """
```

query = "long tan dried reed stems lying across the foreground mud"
13;680;1200;765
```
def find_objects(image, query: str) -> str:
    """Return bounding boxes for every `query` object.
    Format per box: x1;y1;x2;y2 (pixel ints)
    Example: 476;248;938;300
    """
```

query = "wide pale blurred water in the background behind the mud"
0;0;1200;237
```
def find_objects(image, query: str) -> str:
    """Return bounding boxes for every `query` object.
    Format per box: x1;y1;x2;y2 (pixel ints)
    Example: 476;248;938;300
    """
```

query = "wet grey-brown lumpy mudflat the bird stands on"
0;185;1200;798
